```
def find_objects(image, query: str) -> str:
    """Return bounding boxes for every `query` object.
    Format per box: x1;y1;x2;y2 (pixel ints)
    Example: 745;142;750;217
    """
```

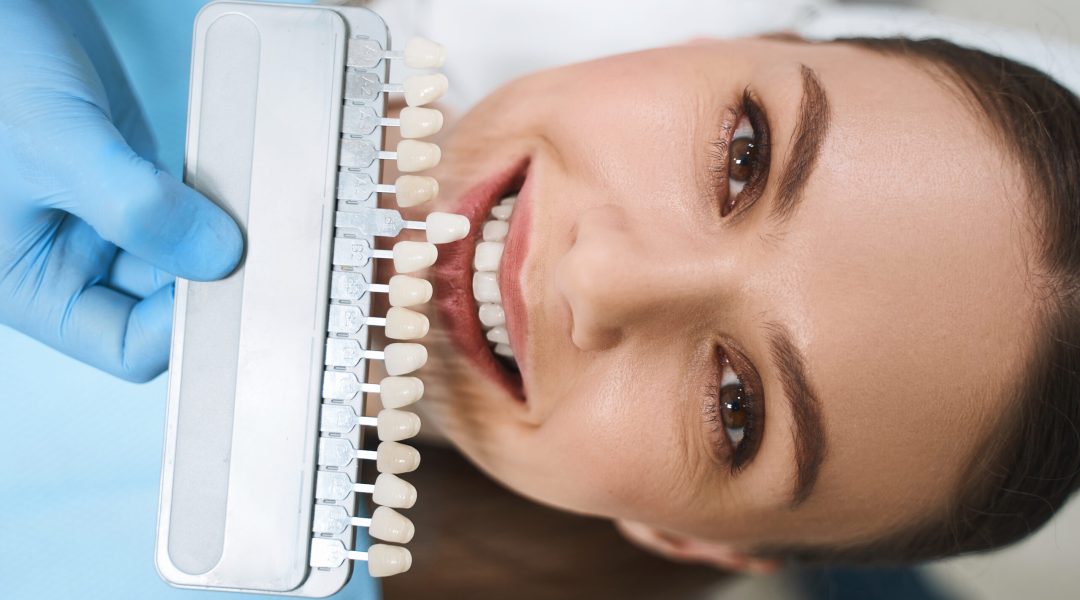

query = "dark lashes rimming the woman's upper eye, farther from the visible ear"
708;87;770;218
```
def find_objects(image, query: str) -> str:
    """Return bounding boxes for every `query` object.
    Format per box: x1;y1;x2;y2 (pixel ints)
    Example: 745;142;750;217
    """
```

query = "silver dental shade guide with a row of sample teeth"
156;0;455;597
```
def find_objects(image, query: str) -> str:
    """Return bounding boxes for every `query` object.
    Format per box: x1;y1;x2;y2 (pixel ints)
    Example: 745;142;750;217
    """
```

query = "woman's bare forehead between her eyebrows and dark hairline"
751;44;1034;535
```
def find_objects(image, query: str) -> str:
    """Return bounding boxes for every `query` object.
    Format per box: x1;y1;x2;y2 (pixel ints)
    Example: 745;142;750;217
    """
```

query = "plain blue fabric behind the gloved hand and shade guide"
0;0;379;600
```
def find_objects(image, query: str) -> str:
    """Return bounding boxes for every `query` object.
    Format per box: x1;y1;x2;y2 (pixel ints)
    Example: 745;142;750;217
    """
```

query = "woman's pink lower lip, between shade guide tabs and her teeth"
433;159;528;401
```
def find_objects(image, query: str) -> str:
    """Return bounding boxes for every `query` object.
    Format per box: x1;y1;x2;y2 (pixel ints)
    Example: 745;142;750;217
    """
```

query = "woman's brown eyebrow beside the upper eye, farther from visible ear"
771;65;829;223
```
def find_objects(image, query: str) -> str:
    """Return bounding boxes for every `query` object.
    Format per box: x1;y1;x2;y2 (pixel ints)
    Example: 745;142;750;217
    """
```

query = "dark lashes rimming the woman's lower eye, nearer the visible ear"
703;350;765;475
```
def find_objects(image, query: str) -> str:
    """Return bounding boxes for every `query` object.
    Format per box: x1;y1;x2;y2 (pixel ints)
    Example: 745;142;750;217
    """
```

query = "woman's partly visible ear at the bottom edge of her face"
615;521;781;574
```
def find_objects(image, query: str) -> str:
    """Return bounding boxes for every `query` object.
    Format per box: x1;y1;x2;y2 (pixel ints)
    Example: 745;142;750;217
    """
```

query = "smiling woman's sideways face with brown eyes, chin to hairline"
386;40;1034;548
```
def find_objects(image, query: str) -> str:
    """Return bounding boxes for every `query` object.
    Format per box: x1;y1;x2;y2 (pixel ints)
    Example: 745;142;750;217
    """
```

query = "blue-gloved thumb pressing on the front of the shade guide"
52;117;243;281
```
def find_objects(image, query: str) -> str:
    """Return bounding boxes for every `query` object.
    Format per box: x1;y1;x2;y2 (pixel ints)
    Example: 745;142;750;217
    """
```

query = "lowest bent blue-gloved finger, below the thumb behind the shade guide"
57;285;174;383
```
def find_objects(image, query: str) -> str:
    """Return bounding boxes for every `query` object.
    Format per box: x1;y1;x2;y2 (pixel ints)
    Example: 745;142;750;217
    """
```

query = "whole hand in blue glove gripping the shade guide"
0;0;243;381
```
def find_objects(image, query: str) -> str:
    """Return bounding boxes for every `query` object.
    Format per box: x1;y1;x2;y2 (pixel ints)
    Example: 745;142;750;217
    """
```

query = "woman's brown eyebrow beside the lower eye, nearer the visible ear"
766;323;827;509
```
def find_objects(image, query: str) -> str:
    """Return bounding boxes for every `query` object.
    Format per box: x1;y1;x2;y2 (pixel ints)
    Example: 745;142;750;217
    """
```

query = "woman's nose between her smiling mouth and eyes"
555;205;716;351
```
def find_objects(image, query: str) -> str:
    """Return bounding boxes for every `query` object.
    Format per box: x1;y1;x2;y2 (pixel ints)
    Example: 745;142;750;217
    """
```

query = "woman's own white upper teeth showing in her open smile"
473;195;517;360
